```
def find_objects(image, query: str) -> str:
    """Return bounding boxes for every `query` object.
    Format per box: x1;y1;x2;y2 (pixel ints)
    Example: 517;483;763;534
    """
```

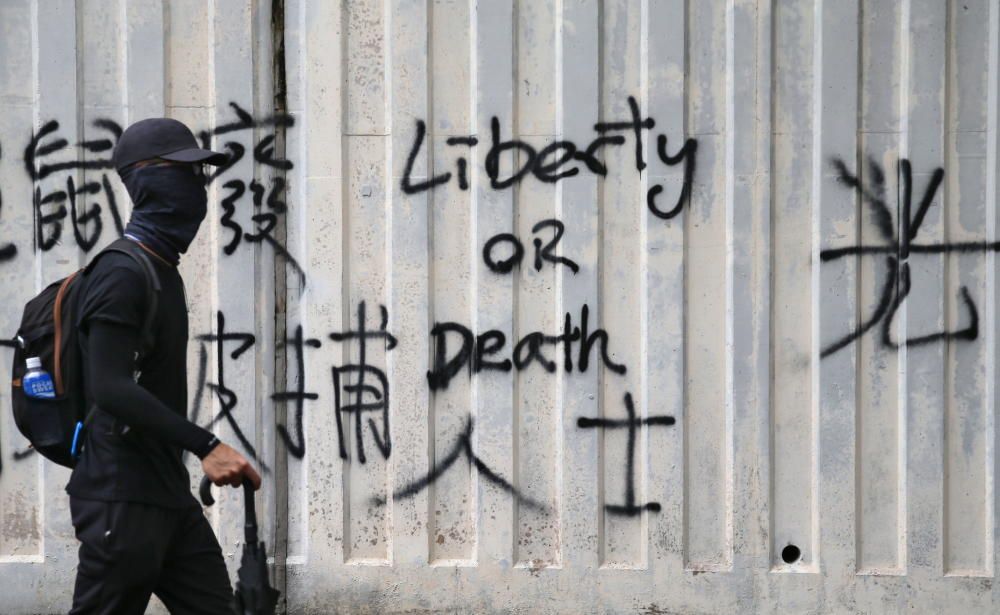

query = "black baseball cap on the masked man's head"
111;117;228;171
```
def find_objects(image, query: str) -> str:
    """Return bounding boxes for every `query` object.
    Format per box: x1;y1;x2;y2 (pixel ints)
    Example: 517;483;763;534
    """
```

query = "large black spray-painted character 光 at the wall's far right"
820;158;980;357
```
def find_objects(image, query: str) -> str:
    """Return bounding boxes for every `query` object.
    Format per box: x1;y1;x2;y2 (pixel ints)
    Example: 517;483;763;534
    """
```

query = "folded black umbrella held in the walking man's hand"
199;476;281;615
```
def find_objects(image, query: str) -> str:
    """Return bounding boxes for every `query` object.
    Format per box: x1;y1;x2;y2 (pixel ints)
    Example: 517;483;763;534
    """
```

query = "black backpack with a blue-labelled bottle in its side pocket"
11;238;160;468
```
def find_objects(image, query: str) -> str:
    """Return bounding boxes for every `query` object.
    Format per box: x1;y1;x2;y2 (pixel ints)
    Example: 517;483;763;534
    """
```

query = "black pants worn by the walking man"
70;496;233;615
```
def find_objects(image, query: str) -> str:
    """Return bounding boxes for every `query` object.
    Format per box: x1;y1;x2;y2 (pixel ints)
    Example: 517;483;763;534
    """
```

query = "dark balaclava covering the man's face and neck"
119;164;208;265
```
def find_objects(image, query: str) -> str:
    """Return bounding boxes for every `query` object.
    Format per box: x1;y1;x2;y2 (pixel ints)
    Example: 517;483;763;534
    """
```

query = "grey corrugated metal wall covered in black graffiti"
0;0;1000;613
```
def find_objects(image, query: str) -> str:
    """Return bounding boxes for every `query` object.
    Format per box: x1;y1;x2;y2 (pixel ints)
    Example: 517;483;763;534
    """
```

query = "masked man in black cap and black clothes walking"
66;118;261;615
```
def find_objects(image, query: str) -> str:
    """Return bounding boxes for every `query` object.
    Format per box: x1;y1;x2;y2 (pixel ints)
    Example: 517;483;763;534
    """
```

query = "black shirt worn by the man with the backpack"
66;248;218;507
